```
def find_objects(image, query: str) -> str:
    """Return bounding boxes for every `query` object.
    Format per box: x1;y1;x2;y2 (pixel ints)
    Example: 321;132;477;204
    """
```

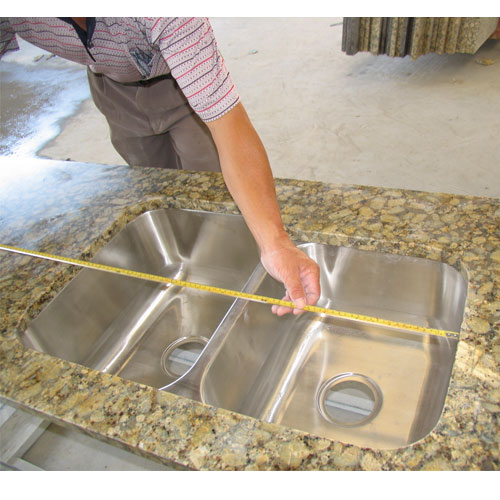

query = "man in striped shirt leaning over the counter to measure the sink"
0;17;320;315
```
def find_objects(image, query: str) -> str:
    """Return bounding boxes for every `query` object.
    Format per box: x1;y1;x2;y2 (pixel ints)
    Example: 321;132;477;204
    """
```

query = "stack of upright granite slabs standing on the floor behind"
342;17;499;58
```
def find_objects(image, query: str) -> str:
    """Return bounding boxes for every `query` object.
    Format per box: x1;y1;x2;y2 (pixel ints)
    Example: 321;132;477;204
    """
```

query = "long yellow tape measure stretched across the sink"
0;245;458;338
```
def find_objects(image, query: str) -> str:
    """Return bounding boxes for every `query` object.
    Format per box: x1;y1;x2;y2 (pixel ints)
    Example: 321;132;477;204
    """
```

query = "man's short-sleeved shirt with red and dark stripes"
0;17;239;122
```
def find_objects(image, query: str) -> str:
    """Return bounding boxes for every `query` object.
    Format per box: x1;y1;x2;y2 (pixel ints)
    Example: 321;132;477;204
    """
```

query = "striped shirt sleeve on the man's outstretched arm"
151;17;239;122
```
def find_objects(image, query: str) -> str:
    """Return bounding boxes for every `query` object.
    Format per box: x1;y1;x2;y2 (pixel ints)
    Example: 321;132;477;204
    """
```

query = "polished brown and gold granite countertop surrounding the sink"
0;158;500;470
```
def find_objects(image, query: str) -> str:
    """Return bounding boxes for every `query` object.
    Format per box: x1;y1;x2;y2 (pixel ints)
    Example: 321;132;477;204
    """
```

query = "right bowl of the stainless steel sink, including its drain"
202;244;466;448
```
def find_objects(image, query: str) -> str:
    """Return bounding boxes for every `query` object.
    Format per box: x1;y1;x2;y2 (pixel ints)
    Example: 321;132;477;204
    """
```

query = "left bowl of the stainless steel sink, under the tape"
22;209;259;387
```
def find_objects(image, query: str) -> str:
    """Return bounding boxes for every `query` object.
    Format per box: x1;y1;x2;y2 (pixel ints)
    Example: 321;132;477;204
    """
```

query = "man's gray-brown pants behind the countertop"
87;70;220;172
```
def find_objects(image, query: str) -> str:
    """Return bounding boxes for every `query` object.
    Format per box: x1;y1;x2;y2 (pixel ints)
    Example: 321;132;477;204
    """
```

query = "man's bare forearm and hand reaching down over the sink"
207;103;320;315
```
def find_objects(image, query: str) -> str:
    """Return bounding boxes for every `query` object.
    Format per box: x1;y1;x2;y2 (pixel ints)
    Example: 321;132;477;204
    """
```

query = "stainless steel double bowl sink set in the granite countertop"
22;209;467;449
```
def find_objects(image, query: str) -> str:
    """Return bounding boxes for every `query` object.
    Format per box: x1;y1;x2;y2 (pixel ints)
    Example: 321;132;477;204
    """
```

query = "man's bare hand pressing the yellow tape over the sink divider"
261;241;320;316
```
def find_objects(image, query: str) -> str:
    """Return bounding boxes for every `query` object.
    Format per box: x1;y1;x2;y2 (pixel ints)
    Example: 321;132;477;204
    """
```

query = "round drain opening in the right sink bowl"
318;373;382;427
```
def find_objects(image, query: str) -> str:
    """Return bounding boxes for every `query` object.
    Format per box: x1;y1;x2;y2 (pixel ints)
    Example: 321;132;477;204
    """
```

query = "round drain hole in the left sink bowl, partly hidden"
160;336;208;379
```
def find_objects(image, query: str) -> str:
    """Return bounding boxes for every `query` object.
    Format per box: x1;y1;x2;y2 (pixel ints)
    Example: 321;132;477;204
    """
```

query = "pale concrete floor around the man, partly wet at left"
0;18;500;470
